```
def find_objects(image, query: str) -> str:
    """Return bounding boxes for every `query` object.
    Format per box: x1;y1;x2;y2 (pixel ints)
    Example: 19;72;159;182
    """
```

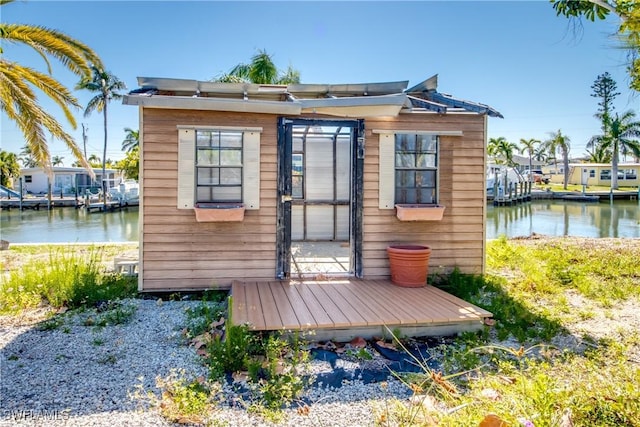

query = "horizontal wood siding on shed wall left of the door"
142;109;276;290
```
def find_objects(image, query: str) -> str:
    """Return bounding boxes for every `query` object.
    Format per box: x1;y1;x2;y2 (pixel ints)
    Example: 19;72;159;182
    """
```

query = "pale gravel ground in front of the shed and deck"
0;299;409;427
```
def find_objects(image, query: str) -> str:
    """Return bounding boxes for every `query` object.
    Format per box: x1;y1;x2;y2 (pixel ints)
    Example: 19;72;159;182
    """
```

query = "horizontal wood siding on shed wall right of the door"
363;114;486;278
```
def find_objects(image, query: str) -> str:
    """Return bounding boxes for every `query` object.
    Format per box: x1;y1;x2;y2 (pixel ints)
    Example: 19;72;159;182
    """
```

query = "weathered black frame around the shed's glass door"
276;117;365;279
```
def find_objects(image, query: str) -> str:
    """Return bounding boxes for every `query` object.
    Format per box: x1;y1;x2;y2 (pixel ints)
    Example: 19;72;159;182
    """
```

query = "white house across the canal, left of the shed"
19;167;122;195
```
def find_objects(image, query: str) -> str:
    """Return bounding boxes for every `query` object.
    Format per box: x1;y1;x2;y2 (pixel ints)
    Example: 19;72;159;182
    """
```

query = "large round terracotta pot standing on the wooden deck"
387;245;431;288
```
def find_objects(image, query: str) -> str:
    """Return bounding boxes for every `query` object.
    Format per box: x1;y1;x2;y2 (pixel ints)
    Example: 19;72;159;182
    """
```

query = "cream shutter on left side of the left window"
178;129;196;209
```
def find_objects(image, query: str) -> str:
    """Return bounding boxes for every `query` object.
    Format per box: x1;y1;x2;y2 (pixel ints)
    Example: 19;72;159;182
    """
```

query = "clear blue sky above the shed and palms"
1;0;640;165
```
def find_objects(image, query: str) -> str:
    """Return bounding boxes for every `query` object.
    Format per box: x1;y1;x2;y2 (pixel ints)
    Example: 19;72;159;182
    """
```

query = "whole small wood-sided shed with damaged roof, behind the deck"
124;76;502;291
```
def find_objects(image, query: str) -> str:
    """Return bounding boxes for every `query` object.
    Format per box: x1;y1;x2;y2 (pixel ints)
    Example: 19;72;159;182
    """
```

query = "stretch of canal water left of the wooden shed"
0;208;138;243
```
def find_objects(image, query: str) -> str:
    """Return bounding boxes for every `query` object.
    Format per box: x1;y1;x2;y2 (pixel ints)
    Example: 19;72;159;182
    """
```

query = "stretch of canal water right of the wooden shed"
487;200;640;239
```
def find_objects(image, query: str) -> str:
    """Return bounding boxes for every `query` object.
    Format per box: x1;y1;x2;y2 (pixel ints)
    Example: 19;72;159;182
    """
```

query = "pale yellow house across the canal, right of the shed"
548;163;640;187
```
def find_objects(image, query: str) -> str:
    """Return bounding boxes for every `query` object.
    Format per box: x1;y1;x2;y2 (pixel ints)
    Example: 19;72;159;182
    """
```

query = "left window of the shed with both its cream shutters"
177;126;262;210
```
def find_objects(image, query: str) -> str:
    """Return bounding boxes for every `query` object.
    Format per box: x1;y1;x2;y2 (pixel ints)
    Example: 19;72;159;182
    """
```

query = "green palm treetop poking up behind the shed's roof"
214;50;300;84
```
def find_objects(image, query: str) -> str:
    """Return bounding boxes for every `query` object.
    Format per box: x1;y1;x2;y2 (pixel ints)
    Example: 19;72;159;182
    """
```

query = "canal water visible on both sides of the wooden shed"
0;200;640;243
